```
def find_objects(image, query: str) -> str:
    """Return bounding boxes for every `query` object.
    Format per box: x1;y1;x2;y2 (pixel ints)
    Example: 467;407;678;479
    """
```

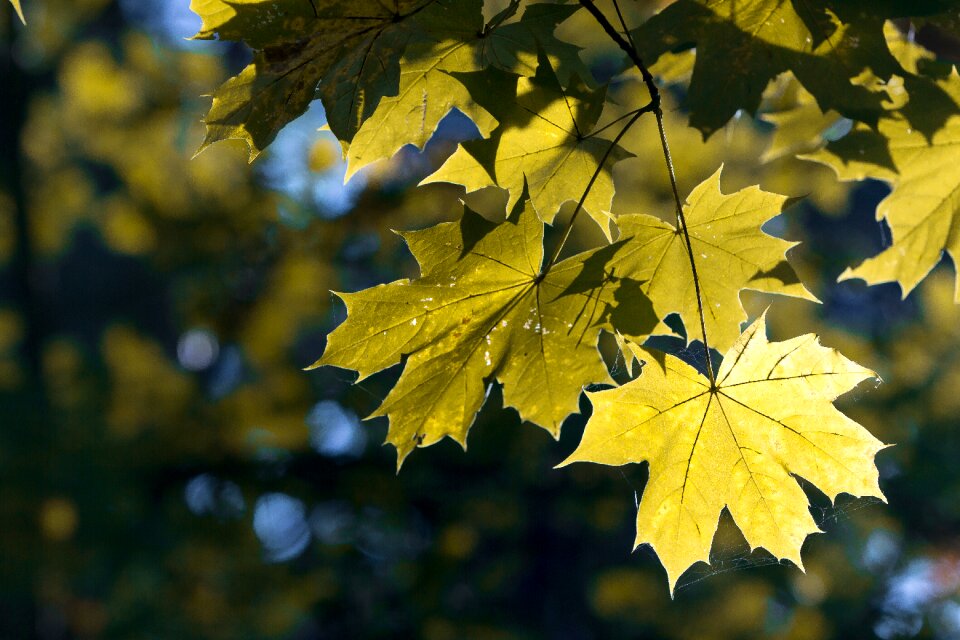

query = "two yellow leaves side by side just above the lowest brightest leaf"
316;166;812;461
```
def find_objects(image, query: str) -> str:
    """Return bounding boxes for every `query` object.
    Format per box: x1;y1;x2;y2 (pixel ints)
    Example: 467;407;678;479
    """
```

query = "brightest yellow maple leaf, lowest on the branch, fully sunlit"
560;317;885;591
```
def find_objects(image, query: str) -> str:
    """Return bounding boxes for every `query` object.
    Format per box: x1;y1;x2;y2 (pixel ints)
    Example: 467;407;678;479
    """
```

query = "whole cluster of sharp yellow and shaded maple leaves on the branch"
184;0;960;586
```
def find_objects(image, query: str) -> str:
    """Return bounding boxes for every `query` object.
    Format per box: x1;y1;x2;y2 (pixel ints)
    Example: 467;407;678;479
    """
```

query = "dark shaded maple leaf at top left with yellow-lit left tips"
190;0;454;160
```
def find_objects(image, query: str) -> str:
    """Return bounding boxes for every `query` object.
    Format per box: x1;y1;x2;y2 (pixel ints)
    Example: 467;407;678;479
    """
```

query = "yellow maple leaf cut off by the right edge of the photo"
803;70;960;302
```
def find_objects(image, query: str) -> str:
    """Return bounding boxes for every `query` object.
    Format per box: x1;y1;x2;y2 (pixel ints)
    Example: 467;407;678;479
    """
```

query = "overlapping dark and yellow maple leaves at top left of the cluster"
191;0;582;168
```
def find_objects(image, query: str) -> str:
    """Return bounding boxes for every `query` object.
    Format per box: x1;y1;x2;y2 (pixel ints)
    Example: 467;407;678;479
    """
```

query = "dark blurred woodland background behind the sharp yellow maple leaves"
0;0;960;640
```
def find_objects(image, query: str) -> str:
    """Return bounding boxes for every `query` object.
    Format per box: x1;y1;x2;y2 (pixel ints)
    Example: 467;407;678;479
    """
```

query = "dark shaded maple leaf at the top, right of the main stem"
633;0;904;137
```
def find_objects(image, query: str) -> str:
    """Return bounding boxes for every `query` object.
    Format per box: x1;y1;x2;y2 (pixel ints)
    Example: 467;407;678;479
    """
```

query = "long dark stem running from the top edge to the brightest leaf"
568;0;717;390
